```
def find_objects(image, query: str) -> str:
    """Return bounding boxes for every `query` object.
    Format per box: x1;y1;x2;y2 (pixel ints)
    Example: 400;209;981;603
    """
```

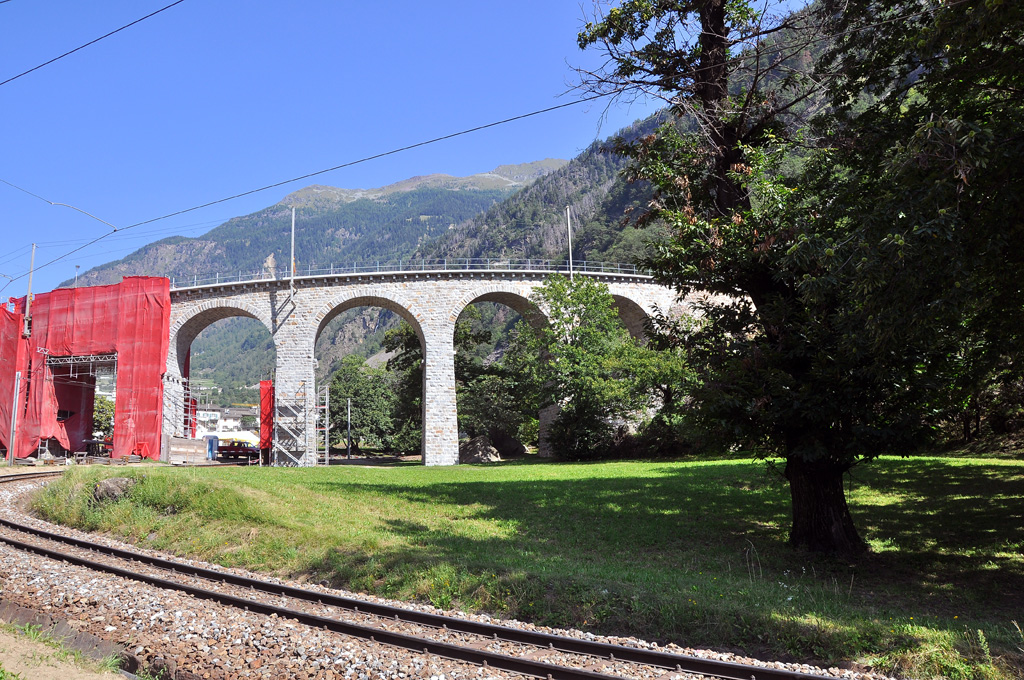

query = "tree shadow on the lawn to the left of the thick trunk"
309;456;788;559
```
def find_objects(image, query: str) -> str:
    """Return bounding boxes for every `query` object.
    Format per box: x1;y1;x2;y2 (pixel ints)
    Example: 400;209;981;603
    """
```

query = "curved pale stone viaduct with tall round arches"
163;268;676;465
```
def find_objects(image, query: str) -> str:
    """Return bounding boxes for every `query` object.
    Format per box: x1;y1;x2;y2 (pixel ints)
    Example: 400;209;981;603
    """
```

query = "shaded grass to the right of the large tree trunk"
853;459;1024;622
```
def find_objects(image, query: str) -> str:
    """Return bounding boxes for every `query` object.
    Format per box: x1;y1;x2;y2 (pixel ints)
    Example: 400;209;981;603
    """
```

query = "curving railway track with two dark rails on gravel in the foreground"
0;472;860;680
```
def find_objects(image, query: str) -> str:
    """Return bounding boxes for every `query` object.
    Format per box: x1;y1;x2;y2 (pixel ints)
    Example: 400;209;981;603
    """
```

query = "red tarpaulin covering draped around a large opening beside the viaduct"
0;277;171;458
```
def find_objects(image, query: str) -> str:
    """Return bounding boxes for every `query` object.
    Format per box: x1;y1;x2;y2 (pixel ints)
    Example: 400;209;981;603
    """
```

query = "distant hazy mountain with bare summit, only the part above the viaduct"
65;159;565;286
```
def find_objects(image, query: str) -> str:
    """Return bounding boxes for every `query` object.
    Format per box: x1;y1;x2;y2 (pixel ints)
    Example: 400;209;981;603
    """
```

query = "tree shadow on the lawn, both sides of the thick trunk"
299;459;1024;621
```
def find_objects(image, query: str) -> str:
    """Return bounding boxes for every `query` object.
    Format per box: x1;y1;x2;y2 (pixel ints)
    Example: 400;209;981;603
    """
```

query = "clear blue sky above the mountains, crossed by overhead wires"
0;0;654;299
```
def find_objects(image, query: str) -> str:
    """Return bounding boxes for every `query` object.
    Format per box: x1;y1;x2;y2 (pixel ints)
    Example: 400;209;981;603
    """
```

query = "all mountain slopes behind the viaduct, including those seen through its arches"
66;119;671;406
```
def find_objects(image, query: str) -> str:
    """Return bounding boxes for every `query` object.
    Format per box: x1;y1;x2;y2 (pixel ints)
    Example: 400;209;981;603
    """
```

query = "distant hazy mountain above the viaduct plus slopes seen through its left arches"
61;159;566;405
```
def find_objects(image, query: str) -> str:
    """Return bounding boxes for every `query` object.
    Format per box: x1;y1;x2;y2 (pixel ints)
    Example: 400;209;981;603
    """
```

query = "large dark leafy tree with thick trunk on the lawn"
580;0;1022;554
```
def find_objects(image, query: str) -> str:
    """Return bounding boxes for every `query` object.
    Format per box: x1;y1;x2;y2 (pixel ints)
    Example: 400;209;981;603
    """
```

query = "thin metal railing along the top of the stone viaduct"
171;257;648;290
